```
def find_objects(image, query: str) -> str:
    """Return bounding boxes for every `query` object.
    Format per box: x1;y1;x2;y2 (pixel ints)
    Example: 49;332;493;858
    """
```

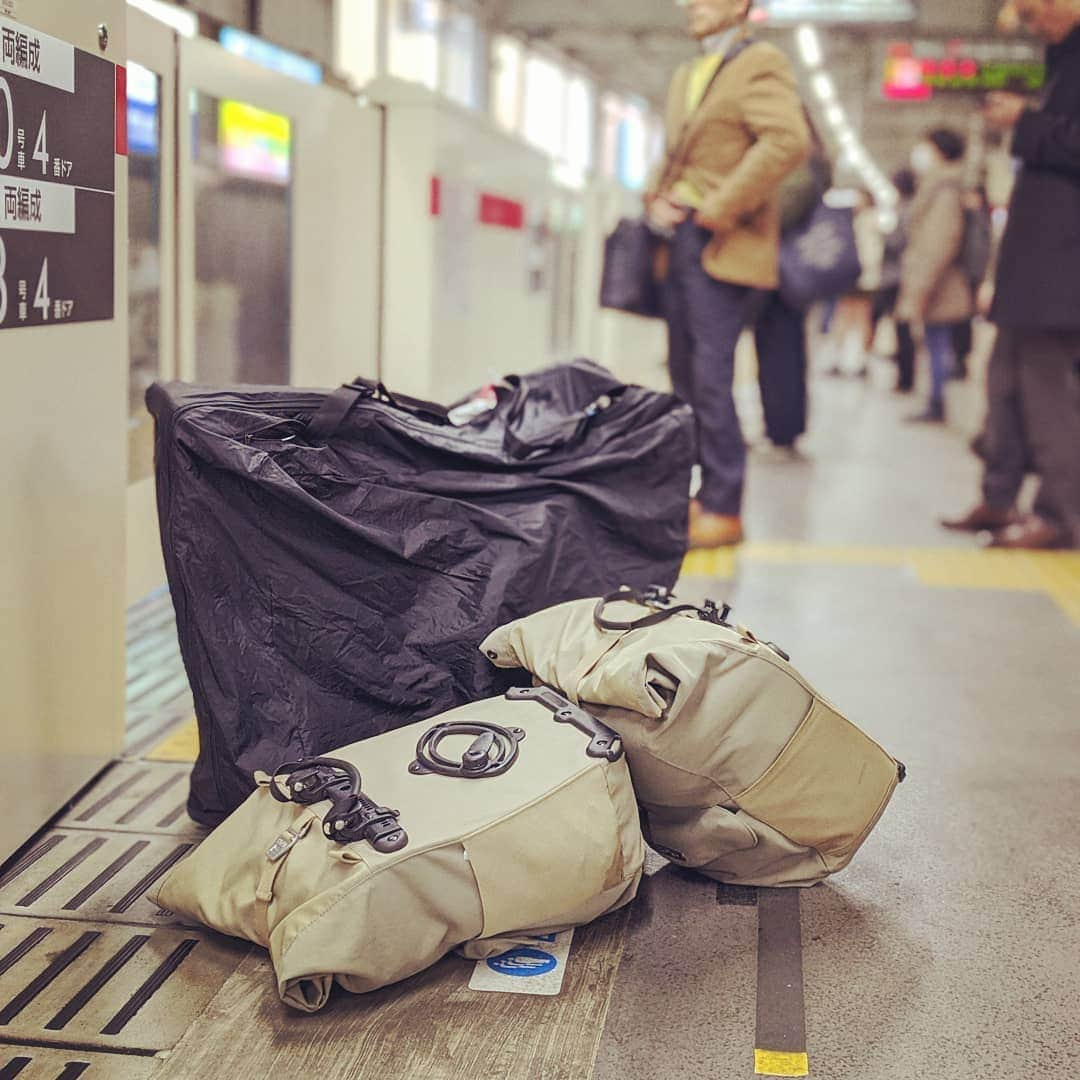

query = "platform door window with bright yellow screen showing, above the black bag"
192;93;293;384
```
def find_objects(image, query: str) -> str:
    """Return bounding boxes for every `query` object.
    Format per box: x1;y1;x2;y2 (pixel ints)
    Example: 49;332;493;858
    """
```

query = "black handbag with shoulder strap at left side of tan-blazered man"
600;38;754;319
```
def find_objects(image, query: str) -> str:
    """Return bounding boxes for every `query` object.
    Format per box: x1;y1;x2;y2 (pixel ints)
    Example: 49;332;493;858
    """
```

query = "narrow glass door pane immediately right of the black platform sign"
127;63;162;483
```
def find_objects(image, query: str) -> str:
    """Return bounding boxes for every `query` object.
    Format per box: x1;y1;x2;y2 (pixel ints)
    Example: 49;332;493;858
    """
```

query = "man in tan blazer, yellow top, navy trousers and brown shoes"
646;0;810;548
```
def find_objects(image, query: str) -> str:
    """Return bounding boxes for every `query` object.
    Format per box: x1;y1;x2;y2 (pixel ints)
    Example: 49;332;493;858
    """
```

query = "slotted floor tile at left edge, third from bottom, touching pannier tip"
0;829;198;927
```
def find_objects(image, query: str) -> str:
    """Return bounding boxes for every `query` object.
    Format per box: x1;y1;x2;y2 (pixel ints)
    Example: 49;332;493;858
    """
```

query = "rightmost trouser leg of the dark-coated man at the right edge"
1020;332;1080;546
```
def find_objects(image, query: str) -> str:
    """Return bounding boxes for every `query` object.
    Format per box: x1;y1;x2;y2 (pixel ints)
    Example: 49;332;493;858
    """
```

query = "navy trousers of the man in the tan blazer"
663;218;753;515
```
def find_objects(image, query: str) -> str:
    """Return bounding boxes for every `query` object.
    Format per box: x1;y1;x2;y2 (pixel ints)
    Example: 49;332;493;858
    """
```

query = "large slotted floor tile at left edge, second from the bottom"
0;916;247;1049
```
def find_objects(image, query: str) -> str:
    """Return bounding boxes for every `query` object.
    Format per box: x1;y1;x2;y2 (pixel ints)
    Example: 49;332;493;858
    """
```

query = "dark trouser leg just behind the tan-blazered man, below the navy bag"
754;293;807;446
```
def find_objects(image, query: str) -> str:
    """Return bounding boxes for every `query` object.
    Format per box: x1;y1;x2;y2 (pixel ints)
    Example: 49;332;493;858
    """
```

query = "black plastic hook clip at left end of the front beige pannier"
270;757;408;854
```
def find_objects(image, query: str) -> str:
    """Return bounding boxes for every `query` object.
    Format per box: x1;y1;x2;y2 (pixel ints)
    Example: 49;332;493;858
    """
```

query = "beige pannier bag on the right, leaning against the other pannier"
481;590;904;886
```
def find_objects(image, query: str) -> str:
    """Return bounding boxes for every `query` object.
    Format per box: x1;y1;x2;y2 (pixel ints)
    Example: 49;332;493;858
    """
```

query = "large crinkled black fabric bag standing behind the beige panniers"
147;361;694;825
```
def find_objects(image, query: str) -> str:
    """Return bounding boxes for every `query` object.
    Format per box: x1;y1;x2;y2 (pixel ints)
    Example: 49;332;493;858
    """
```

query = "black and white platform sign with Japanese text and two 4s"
0;17;116;329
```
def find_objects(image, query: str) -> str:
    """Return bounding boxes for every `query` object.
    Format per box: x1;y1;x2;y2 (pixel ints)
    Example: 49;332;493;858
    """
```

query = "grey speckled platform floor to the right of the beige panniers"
595;381;1080;1080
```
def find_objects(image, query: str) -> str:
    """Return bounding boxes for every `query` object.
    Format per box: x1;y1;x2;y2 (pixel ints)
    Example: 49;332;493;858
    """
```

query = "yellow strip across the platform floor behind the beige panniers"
683;543;1080;625
